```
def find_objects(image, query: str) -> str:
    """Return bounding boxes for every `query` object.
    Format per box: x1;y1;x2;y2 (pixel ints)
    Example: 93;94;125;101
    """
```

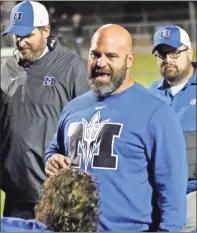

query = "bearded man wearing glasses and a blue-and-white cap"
150;26;197;230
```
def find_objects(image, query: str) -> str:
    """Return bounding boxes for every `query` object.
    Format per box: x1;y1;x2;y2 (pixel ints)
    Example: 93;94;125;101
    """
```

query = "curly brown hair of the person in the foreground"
35;169;99;232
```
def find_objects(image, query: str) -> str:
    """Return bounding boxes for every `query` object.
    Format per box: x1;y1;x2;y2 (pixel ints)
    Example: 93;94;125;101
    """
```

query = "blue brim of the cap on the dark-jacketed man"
1;24;35;36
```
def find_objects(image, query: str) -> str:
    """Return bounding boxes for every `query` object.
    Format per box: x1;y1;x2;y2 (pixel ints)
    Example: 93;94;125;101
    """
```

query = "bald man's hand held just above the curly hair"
45;154;71;176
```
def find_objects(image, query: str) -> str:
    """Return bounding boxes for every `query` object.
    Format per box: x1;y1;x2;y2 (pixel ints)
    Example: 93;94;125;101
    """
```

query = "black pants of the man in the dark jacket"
3;198;35;219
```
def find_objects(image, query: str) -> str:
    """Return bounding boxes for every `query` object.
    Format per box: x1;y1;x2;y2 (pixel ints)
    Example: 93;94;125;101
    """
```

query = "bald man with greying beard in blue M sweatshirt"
45;24;188;232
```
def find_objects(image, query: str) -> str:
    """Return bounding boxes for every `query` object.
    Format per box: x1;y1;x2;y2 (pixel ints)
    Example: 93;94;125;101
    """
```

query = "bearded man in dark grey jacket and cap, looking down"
0;1;88;218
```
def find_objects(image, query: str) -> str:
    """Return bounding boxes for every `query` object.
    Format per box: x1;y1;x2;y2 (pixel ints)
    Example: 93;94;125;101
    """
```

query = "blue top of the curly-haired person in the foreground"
1;217;52;232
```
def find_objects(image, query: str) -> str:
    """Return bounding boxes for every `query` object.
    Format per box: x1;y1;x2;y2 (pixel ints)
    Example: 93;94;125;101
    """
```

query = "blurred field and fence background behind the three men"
0;1;197;86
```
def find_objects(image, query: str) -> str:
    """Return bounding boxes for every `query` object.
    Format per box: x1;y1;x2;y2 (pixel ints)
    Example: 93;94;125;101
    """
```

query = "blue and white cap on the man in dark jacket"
2;1;49;36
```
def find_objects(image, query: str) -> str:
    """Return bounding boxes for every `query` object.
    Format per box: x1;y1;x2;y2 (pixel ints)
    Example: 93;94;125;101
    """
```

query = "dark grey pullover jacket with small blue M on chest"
0;40;88;202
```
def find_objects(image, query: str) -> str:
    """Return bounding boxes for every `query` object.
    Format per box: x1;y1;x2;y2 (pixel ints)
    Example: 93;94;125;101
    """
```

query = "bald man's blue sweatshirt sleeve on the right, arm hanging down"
146;104;188;232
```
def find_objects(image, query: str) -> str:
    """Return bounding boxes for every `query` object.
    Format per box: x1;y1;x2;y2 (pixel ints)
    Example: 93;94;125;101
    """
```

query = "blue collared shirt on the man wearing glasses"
149;62;197;193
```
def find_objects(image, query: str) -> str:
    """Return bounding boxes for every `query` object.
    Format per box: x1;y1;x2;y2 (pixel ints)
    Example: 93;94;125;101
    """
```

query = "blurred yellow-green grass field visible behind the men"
0;51;196;217
